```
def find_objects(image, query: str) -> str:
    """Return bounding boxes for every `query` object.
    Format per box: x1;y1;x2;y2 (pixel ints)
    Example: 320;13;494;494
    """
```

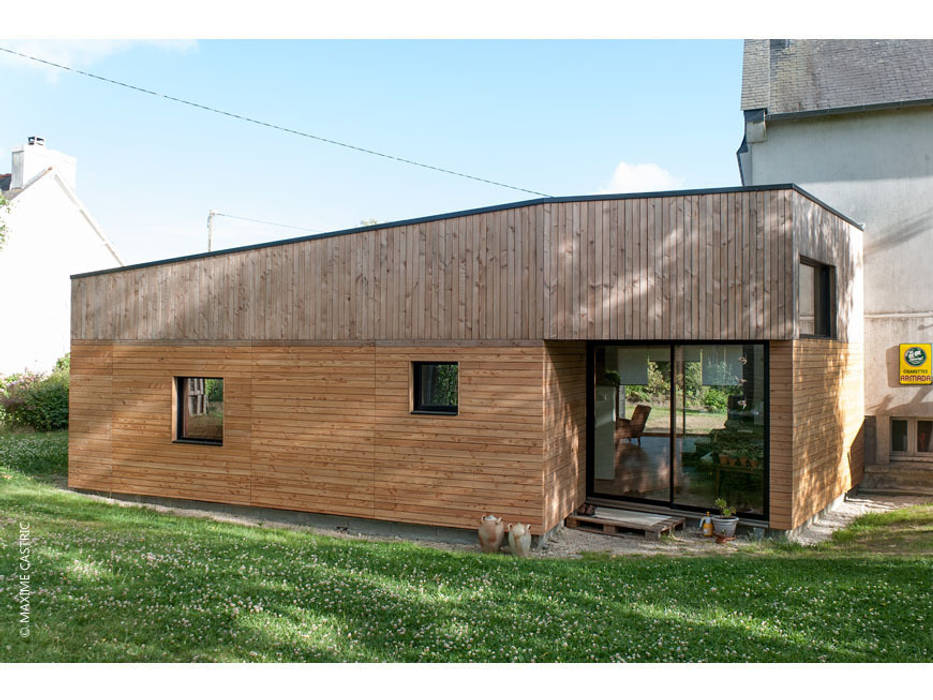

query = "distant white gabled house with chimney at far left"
0;136;123;375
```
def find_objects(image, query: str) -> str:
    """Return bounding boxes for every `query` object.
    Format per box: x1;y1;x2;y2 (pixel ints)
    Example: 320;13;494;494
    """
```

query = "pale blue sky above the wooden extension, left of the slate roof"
0;40;742;263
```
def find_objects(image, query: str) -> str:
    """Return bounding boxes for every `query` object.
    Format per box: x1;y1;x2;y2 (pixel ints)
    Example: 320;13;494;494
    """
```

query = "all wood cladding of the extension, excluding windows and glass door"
69;187;861;533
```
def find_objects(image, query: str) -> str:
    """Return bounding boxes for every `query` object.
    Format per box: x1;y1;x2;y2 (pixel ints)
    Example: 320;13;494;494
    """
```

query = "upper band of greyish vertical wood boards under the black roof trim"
72;189;855;342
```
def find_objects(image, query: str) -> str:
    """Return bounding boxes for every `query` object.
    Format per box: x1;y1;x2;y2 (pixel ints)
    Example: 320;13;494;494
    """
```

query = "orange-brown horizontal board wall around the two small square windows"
69;342;544;533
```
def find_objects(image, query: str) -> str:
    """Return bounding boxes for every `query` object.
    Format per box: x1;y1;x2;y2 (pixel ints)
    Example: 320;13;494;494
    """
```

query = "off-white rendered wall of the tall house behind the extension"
745;107;933;463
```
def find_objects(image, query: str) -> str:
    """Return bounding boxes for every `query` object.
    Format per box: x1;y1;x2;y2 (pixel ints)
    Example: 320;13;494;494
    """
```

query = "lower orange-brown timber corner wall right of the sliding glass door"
770;338;864;529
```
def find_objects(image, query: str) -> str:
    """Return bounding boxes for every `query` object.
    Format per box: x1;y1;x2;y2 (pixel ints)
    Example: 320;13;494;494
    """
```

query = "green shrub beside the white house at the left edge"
0;355;70;431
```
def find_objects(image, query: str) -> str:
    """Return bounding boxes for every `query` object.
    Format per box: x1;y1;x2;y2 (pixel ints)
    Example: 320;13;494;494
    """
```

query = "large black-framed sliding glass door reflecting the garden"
588;343;767;516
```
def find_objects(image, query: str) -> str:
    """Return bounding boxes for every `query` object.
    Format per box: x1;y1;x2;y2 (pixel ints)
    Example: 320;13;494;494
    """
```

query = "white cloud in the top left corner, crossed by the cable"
0;39;197;83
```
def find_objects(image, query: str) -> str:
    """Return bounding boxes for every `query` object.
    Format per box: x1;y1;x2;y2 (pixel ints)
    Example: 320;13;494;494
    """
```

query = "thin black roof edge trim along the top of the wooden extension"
71;183;864;279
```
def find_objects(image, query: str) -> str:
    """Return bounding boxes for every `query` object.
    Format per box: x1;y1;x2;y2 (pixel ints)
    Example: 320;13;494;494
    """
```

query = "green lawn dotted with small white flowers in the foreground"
0;434;933;662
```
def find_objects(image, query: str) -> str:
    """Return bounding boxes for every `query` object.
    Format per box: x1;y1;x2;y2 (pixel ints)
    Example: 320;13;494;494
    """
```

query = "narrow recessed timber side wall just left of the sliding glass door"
544;341;586;530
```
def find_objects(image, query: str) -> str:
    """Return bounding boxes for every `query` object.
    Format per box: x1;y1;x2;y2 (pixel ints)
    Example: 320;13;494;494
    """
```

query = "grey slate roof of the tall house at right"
742;39;933;117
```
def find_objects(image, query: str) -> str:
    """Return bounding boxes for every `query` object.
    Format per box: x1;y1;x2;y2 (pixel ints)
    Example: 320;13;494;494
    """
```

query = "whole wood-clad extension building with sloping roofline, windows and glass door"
68;185;864;534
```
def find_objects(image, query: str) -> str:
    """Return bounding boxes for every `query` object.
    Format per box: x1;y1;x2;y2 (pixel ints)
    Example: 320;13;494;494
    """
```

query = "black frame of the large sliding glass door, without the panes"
586;340;771;521
